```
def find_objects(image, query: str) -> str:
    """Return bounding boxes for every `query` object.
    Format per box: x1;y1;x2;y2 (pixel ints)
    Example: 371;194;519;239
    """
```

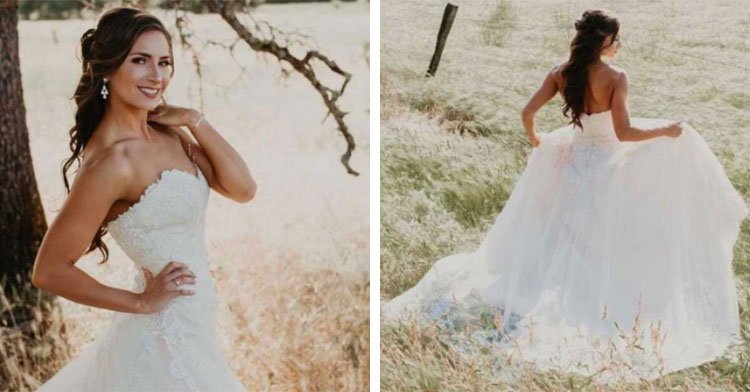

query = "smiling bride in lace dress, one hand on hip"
32;8;256;391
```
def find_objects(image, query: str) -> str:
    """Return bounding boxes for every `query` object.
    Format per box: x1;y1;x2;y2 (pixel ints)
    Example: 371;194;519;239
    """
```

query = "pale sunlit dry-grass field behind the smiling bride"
0;3;370;391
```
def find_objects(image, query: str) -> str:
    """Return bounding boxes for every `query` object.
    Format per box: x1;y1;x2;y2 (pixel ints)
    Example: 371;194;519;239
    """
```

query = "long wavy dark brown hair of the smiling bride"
62;7;174;264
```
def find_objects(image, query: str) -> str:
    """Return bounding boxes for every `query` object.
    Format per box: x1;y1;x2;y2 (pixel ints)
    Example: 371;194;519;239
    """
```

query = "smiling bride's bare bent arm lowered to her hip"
31;153;197;313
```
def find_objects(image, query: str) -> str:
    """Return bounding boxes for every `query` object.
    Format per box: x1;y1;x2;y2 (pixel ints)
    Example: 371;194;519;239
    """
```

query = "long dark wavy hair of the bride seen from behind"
562;10;620;128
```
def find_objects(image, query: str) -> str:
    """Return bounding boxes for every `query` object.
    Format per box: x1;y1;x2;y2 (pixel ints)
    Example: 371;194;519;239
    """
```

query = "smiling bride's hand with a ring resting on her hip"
138;261;195;313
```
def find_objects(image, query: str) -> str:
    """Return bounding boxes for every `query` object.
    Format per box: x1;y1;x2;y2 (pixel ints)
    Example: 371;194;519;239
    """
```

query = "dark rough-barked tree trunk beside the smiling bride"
0;0;47;329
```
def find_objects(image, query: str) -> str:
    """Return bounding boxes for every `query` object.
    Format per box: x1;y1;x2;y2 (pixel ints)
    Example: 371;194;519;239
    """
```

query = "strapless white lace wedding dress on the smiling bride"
38;162;245;392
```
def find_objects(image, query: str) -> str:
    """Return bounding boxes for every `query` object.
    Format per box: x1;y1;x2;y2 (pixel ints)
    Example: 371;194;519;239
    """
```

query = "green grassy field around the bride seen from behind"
380;0;750;391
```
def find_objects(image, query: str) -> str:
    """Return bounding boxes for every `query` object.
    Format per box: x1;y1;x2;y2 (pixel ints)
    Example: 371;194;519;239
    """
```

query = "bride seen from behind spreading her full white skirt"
382;10;748;381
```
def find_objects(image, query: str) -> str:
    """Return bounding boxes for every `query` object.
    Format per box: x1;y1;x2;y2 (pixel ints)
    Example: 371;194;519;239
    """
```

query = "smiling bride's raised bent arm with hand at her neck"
149;105;257;203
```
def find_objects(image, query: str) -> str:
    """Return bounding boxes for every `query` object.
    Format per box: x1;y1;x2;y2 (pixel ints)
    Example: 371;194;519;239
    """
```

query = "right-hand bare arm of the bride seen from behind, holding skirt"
612;71;682;142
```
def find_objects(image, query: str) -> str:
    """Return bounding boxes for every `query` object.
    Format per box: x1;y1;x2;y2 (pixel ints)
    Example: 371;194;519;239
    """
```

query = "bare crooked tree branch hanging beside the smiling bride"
208;0;359;176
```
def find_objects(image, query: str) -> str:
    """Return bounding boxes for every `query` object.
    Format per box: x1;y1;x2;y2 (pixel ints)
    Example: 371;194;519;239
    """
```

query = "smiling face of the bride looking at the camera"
107;30;172;110
